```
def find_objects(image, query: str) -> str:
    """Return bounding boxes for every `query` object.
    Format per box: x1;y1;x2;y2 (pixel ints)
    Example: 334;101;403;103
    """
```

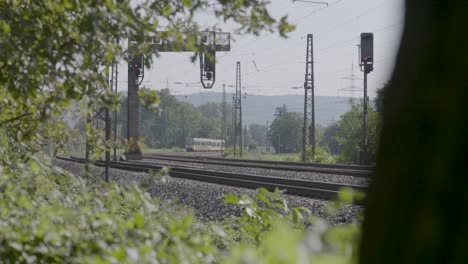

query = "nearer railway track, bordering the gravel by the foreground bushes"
57;157;366;200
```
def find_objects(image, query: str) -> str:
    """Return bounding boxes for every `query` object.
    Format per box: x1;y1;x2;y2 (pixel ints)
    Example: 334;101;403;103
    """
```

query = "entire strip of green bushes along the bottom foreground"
0;158;360;263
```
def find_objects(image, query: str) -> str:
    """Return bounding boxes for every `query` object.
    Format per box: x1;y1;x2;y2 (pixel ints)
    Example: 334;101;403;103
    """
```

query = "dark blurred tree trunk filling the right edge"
360;0;468;264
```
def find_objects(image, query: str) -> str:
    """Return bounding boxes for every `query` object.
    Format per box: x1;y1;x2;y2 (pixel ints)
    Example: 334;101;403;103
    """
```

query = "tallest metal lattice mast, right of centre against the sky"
302;34;315;162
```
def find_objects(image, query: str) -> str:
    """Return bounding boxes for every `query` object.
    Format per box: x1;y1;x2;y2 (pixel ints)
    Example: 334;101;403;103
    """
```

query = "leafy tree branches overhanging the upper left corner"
0;0;294;163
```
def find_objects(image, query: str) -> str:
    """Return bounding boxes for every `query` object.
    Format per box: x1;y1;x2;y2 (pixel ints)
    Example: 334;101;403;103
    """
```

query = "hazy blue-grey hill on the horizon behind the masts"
176;92;350;126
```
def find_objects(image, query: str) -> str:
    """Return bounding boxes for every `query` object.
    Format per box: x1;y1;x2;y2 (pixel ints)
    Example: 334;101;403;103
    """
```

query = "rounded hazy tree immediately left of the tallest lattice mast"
270;112;303;153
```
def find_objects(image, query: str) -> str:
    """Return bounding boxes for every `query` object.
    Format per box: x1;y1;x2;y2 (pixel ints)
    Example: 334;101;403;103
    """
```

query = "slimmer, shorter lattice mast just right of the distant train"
234;61;242;157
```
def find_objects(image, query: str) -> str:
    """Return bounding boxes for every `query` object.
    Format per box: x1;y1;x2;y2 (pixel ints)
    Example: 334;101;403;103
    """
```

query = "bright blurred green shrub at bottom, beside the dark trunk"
221;189;360;264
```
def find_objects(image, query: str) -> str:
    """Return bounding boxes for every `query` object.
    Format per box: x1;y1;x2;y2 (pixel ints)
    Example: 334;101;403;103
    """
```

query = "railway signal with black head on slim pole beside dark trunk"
359;33;374;165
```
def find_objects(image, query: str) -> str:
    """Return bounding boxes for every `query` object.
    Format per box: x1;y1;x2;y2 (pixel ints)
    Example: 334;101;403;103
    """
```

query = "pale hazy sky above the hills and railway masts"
119;0;404;100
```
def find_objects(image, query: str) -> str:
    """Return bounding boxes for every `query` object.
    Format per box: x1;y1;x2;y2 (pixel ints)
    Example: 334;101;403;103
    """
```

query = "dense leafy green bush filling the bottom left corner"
0;159;217;263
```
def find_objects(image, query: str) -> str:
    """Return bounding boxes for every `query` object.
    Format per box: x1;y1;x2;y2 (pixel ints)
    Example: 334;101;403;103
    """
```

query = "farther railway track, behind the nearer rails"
144;154;374;177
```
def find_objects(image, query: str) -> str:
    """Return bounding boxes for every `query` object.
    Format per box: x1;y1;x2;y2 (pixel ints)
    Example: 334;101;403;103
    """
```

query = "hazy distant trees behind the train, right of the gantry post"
123;89;226;148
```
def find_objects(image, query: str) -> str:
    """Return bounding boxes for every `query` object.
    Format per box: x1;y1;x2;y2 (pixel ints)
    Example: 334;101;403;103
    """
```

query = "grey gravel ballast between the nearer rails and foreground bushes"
54;160;362;224
